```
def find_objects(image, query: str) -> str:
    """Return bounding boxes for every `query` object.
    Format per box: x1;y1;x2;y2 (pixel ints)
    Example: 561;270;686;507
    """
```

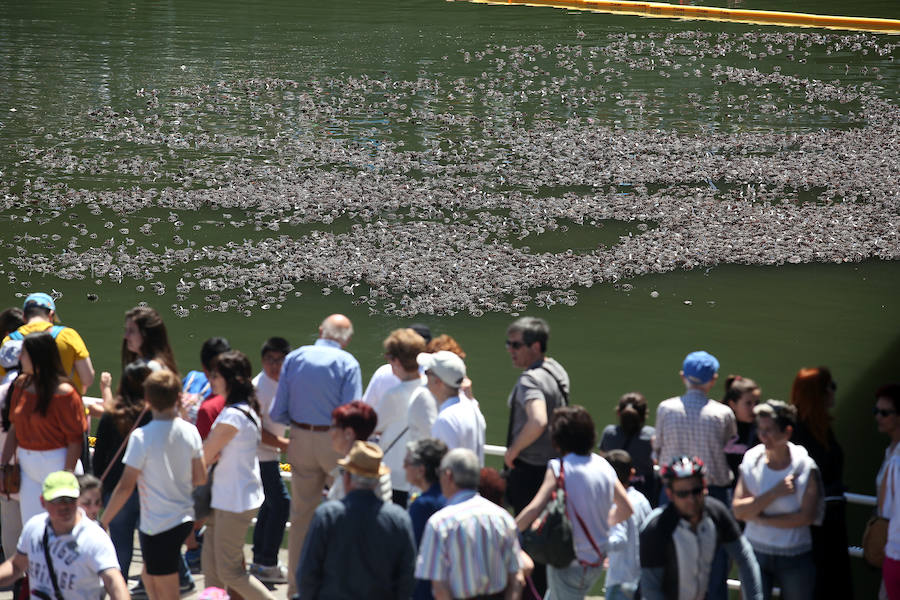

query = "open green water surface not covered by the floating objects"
0;0;900;592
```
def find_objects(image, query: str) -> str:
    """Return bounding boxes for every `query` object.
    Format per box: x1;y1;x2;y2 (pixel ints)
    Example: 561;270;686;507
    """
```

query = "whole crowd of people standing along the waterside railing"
0;293;900;600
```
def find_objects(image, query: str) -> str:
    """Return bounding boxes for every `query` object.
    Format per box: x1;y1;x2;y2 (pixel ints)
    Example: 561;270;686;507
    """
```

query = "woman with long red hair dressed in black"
791;367;853;598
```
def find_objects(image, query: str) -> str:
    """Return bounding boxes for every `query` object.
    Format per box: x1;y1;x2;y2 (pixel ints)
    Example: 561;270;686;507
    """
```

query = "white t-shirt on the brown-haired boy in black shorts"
122;417;203;535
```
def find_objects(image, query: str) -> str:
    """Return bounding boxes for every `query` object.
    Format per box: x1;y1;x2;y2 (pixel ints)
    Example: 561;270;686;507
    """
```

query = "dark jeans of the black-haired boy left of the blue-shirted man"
253;460;291;567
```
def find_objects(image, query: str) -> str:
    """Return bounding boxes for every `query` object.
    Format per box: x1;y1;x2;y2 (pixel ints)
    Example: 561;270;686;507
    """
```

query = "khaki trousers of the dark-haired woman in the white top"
200;508;275;600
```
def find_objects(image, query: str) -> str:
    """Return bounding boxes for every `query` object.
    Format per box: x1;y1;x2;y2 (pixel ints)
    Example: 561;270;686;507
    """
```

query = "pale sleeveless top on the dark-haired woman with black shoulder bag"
547;453;619;563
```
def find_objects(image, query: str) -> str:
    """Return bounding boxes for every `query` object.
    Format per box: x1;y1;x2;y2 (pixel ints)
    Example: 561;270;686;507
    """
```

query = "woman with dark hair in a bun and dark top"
599;392;659;507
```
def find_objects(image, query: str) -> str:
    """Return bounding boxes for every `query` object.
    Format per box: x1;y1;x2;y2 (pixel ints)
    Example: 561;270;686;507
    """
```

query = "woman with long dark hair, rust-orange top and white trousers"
0;332;88;524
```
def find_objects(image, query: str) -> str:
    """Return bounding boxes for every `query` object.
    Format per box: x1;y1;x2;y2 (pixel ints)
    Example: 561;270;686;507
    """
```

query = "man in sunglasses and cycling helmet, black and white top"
640;456;763;600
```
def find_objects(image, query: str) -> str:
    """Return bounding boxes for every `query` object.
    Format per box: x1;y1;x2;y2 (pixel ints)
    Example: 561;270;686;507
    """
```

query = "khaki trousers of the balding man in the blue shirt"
287;427;343;598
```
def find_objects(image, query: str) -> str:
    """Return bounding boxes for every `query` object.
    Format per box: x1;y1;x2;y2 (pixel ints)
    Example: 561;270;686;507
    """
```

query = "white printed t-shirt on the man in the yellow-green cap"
16;508;119;600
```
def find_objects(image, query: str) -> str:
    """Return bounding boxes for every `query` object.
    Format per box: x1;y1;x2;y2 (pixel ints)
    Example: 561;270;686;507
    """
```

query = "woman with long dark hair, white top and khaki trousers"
201;350;274;600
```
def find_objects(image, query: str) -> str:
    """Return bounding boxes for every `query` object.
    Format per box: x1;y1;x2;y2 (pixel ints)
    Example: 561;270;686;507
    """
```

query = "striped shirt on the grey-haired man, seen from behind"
416;490;521;598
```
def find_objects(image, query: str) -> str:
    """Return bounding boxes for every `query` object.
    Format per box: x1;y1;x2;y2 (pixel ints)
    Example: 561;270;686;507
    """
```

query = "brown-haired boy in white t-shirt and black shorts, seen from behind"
101;370;206;600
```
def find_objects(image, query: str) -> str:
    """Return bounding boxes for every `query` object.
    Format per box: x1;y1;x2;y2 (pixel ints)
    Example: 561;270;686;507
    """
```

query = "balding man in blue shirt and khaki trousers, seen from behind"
269;314;362;597
